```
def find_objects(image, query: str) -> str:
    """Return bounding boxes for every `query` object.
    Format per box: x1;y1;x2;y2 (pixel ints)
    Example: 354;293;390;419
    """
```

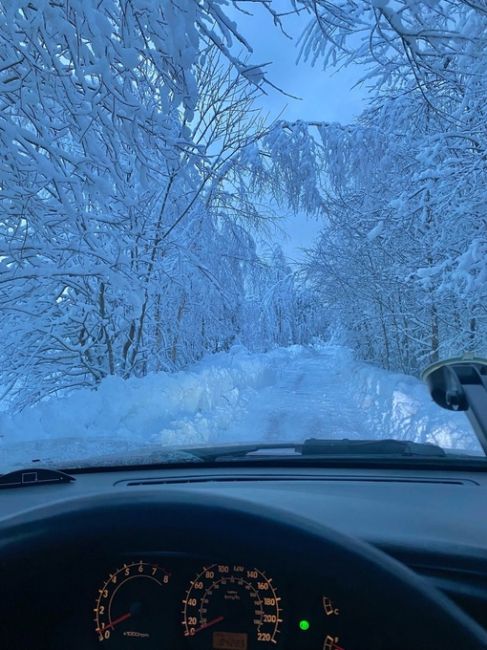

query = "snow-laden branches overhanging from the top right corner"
294;0;487;103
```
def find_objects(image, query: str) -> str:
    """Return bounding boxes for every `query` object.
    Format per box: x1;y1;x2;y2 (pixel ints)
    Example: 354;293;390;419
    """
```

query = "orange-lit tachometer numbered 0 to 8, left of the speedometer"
94;560;170;648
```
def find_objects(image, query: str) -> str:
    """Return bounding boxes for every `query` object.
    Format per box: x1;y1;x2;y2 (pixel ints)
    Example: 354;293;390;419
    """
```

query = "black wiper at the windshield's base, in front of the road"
186;438;447;462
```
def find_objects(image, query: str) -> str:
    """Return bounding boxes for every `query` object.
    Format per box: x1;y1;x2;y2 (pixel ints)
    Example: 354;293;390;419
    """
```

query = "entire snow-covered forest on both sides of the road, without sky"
0;0;487;409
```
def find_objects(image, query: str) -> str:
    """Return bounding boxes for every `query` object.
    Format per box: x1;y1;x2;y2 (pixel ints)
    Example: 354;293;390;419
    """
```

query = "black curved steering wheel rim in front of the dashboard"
0;487;487;650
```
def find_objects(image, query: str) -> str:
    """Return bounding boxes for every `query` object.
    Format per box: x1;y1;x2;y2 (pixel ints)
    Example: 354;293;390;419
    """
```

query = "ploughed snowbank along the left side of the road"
0;347;300;464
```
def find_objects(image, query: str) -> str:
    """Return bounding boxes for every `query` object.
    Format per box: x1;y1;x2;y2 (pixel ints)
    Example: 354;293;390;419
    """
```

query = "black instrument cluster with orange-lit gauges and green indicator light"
66;555;347;650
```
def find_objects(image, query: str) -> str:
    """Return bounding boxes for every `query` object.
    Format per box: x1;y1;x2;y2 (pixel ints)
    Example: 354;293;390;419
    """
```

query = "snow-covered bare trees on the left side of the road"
0;0;328;407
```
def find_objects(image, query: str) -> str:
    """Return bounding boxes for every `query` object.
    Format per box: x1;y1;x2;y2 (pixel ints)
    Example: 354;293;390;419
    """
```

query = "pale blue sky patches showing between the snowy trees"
231;0;367;260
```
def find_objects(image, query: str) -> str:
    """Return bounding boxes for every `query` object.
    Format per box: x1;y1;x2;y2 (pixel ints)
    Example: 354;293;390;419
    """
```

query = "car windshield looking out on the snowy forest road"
0;0;487;472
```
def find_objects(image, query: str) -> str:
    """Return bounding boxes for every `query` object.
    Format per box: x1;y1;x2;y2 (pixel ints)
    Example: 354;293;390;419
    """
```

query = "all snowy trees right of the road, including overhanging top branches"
305;0;487;373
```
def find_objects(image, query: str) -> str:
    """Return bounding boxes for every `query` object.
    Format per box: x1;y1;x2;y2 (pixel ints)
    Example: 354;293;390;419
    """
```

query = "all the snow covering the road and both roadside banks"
0;345;478;469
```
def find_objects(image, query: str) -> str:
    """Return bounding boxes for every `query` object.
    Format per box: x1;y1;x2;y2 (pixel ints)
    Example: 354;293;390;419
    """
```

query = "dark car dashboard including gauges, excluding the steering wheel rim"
0;466;487;650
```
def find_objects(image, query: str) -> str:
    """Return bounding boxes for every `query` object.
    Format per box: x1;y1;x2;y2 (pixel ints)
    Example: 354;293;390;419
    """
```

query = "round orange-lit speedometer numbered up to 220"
182;564;282;650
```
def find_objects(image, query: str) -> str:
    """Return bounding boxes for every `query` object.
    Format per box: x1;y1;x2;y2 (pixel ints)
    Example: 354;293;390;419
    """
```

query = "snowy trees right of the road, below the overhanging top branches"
307;86;487;372
